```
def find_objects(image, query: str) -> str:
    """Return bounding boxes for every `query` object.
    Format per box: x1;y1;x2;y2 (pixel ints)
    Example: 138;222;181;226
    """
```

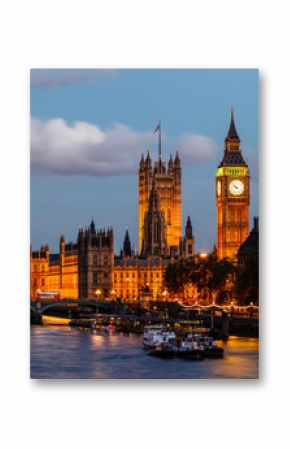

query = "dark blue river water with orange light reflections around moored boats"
31;326;259;379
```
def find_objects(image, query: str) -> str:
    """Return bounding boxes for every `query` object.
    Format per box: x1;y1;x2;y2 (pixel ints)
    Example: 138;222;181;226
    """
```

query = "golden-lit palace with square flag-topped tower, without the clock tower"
31;125;194;300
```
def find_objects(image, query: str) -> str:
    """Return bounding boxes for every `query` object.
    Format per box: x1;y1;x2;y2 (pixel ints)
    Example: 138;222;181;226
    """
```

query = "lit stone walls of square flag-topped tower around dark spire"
139;152;182;254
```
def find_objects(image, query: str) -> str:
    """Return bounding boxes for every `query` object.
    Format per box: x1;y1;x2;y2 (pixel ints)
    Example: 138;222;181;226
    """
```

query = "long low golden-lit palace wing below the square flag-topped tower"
30;217;194;301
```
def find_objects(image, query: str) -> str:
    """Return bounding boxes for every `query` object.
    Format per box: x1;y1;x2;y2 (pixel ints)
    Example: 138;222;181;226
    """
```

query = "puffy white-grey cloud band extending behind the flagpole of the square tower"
31;118;215;176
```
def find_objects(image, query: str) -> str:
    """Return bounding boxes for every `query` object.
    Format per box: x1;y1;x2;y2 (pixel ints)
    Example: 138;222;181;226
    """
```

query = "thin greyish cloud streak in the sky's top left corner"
30;69;116;89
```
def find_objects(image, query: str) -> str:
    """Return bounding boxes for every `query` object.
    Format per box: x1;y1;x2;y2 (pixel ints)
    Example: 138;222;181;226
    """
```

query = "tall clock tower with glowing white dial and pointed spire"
216;109;250;260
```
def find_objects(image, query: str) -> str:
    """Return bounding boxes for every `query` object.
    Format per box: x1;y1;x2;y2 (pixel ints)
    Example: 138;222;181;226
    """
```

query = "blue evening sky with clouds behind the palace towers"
31;69;259;252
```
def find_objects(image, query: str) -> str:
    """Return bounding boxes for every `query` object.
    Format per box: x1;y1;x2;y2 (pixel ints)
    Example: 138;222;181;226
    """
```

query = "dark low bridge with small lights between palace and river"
30;299;259;336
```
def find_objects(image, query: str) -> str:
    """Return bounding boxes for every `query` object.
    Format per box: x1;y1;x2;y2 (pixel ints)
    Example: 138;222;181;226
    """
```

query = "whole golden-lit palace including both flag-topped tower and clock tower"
30;111;254;300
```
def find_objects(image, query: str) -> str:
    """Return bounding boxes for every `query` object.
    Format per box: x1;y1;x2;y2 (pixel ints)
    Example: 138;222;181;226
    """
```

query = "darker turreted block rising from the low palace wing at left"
78;221;114;299
